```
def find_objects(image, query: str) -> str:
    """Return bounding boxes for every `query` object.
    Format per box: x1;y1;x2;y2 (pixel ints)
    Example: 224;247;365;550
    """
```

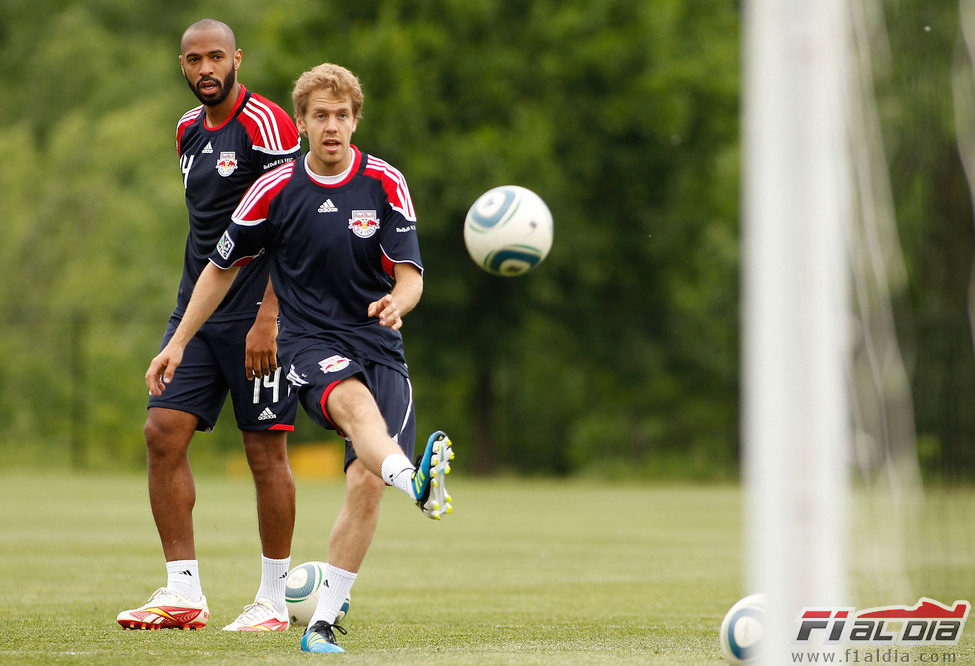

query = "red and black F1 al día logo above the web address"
795;597;971;645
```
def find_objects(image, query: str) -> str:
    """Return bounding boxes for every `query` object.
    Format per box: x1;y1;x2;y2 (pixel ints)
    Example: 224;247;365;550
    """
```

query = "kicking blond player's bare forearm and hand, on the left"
146;263;240;396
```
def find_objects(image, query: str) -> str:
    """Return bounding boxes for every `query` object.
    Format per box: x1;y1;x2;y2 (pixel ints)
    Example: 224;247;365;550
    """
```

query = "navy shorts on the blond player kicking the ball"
288;342;416;469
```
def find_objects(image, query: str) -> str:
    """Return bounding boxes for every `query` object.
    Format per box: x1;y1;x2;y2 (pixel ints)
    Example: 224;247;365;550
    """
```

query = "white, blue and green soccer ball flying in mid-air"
464;185;552;277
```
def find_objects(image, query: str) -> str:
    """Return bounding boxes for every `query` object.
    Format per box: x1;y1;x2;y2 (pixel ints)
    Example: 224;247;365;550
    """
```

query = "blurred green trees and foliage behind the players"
0;0;975;479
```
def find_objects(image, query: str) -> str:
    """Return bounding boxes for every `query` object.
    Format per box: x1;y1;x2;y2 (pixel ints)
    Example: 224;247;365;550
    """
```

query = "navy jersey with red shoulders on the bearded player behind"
173;86;300;322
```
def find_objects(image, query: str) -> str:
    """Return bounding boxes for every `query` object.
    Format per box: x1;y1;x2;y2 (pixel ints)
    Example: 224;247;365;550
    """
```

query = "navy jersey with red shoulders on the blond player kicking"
210;146;423;373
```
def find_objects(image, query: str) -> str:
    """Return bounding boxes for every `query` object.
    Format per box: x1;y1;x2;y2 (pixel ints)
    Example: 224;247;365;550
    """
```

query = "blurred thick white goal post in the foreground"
742;0;852;664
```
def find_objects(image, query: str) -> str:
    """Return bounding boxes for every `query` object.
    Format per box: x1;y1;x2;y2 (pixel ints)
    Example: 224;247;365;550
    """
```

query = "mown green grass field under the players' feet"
0;472;975;664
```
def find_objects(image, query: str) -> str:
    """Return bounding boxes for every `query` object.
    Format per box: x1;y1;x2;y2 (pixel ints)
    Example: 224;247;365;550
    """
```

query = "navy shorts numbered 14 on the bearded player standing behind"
149;317;298;432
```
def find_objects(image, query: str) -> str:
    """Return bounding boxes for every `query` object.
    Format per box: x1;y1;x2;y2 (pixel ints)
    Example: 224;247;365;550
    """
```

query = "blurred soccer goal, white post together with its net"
742;0;975;663
